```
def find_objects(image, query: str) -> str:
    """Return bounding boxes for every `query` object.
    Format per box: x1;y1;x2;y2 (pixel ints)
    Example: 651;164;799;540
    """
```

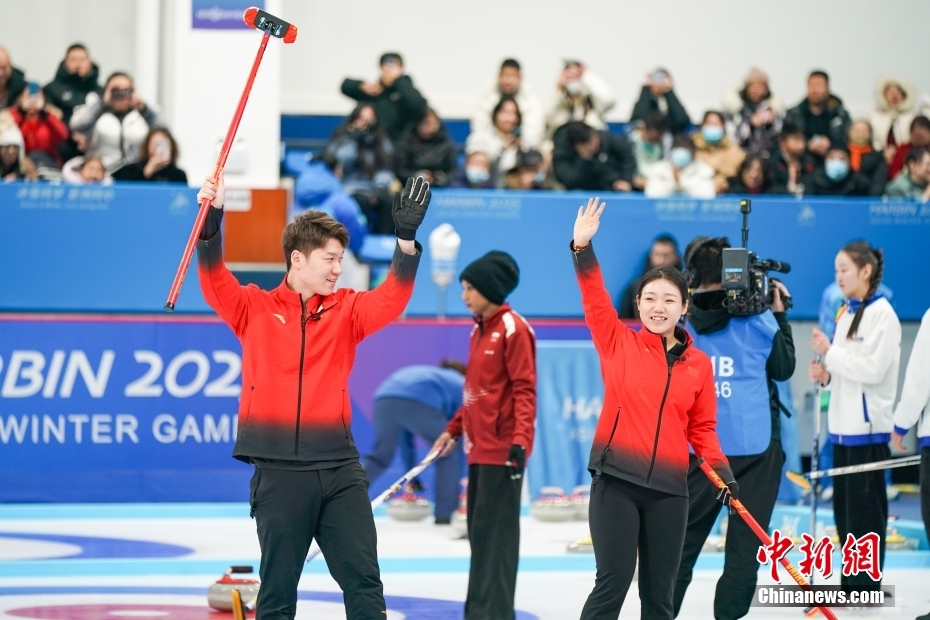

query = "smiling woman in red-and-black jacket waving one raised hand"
571;198;739;620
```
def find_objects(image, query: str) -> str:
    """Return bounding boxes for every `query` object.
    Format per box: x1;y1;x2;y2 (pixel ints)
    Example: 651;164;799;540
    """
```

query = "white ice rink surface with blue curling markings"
0;504;930;620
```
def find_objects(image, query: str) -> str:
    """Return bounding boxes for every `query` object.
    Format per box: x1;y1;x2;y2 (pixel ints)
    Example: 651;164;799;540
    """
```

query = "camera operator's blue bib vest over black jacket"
689;292;795;456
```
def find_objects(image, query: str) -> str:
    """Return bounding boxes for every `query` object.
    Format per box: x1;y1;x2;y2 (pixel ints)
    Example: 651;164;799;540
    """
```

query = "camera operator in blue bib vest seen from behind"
675;237;795;619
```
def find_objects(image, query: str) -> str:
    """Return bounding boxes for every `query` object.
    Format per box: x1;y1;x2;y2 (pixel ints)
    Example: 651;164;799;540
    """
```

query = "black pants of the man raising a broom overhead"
251;462;385;620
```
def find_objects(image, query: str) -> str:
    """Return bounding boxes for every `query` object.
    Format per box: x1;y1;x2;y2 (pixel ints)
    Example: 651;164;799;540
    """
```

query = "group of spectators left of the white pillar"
0;43;187;184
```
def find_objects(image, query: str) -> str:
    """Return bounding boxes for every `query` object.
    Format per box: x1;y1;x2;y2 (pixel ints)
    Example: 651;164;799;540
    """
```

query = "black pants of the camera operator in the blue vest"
675;441;785;620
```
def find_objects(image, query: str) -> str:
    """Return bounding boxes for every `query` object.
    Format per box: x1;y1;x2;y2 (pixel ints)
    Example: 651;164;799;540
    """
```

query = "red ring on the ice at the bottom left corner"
6;603;232;620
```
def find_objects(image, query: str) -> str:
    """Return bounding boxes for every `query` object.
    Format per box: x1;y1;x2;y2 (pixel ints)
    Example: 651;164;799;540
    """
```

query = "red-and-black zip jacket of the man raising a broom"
197;233;420;462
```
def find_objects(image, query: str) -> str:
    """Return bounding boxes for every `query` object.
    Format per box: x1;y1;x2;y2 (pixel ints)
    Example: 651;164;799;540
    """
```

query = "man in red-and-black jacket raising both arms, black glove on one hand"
197;175;430;620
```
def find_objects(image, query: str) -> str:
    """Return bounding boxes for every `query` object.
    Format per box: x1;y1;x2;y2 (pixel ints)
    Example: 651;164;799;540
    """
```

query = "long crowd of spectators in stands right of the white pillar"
327;53;930;229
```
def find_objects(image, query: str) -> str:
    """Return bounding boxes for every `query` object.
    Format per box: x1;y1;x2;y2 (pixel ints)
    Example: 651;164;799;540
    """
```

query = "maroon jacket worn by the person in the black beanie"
446;304;536;465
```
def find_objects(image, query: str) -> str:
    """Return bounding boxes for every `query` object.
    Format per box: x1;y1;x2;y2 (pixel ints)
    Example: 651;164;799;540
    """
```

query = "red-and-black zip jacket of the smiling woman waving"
573;245;733;496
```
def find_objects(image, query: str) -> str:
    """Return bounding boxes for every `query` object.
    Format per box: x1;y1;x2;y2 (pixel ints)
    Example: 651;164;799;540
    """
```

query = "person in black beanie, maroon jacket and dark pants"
433;251;536;620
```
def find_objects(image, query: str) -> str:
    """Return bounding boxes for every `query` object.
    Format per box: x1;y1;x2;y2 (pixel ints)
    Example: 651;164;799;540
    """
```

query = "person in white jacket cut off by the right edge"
891;310;930;618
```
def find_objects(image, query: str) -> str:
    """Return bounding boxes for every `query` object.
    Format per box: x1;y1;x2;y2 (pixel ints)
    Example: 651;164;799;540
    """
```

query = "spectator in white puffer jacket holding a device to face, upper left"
70;72;165;172
